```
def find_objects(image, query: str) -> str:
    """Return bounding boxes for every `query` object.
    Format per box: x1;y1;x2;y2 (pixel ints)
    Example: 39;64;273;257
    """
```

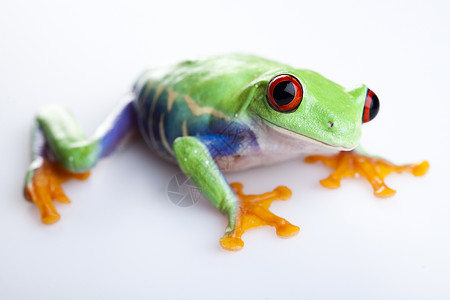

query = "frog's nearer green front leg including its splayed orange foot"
173;137;299;250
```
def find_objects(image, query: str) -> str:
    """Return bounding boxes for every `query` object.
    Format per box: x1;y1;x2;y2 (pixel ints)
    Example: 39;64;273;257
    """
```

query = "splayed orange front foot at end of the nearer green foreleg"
220;183;300;251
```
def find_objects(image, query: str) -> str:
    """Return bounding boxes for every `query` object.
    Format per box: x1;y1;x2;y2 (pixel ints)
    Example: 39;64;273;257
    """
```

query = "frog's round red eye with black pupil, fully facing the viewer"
267;74;303;112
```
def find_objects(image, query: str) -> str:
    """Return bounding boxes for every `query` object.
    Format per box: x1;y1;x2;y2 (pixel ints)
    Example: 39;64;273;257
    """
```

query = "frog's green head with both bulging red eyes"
248;69;379;150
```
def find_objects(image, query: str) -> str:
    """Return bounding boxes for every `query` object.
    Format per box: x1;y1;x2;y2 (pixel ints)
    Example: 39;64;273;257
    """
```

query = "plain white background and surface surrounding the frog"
0;0;450;300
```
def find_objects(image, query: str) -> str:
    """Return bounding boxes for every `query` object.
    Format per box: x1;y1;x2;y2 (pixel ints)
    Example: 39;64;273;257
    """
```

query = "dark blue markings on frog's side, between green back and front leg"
135;83;258;158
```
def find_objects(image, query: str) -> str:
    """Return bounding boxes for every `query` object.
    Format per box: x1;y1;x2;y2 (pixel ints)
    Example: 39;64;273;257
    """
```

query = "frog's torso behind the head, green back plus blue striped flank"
134;54;286;161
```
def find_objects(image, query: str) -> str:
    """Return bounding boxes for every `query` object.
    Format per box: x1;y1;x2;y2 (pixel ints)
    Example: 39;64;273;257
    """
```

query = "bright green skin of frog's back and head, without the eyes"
136;54;367;150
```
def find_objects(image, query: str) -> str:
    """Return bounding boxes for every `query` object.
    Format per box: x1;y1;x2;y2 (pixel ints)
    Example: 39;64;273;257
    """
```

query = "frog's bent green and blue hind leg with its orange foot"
24;95;136;224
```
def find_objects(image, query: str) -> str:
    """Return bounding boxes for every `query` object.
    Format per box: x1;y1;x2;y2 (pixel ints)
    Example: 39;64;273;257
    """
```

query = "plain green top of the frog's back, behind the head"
135;54;288;116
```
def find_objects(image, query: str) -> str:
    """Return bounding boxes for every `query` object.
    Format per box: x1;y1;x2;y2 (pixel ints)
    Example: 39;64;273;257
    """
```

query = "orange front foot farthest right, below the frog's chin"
305;151;430;198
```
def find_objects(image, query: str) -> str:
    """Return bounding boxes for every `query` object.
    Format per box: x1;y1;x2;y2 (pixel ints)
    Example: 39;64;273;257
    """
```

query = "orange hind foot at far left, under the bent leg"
25;159;89;224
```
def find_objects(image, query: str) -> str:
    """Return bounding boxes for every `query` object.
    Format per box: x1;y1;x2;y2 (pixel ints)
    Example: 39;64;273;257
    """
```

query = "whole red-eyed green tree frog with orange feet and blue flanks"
24;54;429;251
